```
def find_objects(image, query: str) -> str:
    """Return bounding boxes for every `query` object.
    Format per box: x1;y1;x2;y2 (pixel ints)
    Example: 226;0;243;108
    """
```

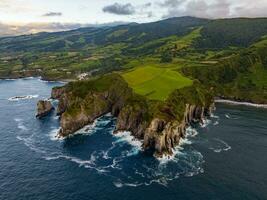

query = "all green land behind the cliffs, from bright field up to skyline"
0;17;267;102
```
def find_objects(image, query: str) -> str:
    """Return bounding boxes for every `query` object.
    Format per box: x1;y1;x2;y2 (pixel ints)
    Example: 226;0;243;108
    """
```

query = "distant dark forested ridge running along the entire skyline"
0;17;267;53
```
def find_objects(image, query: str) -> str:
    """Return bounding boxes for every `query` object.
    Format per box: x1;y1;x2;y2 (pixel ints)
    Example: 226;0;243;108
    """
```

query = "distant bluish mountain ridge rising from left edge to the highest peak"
0;17;209;53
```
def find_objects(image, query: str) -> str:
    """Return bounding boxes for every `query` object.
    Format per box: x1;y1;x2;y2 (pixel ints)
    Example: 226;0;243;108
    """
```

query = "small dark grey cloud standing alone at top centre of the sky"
103;3;136;15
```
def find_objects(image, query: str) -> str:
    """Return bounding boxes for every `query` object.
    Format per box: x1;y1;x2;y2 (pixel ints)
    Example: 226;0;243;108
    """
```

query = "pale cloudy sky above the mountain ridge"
0;0;267;34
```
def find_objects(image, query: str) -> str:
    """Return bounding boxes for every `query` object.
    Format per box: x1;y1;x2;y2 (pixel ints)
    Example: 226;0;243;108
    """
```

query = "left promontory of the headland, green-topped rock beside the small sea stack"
52;75;132;137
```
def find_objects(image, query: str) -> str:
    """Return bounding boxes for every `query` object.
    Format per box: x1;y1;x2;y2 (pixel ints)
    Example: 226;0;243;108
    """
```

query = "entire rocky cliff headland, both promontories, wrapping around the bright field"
52;74;215;156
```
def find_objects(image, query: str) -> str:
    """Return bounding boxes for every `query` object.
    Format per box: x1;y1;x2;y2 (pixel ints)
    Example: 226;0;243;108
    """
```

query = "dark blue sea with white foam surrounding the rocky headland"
0;78;267;200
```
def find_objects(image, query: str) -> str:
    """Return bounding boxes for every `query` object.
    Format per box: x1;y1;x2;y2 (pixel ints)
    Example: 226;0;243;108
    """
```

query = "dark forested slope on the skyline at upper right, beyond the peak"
196;18;267;49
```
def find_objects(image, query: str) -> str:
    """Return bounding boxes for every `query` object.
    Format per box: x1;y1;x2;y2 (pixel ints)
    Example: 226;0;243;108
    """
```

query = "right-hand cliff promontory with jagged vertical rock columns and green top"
116;86;214;157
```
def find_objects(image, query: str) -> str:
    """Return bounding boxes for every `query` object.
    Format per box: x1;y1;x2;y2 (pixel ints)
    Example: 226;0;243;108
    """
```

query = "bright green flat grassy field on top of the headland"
122;65;192;101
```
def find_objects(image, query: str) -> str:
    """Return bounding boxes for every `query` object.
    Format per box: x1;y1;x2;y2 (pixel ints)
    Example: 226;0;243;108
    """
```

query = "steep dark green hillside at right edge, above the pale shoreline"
182;37;267;103
